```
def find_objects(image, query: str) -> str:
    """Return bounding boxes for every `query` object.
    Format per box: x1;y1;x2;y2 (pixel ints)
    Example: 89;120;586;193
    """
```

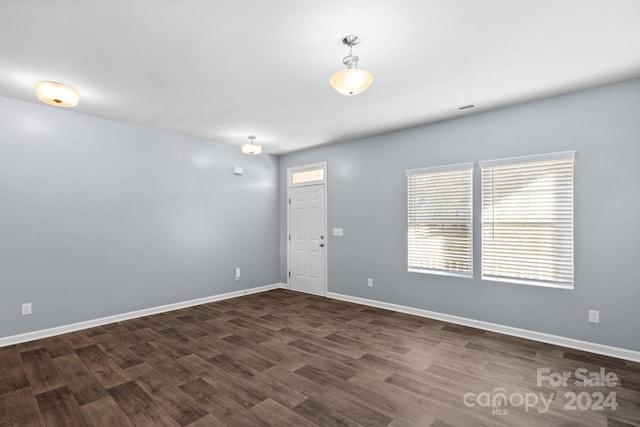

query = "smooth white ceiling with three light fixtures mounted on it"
0;0;640;154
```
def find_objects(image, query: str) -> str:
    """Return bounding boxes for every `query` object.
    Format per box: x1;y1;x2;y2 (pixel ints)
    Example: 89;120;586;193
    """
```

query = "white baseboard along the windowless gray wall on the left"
0;283;287;347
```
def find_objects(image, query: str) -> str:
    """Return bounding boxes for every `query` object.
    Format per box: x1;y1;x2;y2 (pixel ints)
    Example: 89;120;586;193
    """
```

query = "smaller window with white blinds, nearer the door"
406;163;473;277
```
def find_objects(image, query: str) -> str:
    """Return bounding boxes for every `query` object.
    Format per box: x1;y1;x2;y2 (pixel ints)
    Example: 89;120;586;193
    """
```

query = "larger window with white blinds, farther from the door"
480;151;575;288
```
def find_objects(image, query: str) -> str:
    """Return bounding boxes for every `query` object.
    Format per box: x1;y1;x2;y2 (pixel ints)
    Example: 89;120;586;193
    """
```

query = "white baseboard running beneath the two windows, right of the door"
327;292;640;362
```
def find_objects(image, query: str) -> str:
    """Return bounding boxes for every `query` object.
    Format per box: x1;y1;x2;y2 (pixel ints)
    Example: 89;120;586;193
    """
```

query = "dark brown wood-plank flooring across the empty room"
0;290;640;427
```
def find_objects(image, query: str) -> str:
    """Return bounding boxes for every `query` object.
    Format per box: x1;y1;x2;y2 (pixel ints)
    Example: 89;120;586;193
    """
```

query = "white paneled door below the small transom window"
289;184;326;295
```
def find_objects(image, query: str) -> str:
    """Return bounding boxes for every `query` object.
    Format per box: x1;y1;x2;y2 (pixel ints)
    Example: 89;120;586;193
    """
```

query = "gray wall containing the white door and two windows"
280;79;640;350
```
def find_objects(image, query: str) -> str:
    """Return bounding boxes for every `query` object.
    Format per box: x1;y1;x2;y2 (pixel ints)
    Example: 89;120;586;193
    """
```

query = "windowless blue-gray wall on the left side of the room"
0;98;279;337
